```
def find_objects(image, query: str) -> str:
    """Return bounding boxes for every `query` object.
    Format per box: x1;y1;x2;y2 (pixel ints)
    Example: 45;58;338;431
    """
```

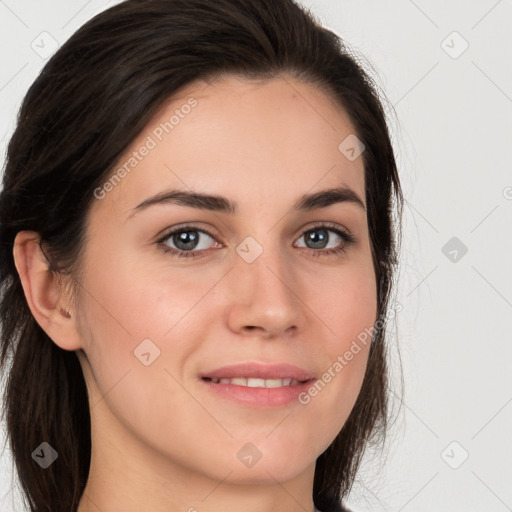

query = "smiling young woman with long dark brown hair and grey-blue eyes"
0;0;403;512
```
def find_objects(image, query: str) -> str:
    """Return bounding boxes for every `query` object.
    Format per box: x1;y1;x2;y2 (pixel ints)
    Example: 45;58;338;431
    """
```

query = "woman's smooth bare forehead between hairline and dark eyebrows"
92;75;365;216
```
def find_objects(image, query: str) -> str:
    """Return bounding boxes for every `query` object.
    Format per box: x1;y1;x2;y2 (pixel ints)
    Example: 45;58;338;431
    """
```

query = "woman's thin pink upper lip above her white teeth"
200;363;314;381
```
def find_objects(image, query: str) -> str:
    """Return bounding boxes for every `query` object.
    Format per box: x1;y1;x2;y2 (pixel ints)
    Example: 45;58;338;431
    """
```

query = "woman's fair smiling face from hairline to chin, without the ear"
73;76;377;483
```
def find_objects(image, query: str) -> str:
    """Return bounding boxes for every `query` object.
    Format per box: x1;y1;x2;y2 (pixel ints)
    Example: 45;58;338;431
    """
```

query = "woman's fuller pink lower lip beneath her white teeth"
201;379;314;408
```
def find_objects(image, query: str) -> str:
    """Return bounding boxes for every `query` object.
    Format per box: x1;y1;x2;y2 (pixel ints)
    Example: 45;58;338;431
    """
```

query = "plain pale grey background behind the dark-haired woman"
0;0;512;512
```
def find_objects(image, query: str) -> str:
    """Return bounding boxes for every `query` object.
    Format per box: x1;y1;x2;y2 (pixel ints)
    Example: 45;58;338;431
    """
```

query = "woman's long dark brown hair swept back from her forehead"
0;0;403;512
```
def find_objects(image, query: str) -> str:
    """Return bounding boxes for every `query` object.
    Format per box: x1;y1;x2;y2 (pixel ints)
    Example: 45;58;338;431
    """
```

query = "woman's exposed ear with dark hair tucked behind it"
13;231;82;350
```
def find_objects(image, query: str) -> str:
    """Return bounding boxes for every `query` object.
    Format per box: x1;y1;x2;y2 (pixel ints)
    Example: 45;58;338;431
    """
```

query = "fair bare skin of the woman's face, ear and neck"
14;76;377;512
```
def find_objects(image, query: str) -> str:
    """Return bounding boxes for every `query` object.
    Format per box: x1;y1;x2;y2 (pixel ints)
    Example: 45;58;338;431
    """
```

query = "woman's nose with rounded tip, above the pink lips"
227;244;304;339
